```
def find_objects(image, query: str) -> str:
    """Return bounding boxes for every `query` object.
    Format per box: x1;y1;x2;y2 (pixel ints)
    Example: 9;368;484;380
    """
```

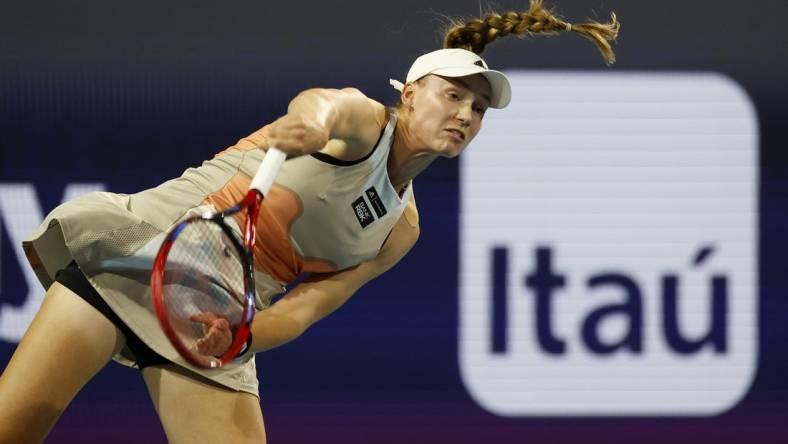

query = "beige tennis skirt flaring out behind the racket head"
22;190;283;396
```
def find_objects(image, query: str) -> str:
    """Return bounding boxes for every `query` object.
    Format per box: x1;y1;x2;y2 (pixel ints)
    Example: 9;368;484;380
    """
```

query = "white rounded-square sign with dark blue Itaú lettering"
459;71;758;416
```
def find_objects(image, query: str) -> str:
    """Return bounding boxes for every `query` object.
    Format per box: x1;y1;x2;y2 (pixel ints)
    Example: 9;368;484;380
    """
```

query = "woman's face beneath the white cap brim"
406;74;491;157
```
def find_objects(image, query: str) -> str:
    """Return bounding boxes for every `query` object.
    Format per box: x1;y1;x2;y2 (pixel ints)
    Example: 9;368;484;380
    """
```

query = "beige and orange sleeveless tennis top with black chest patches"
201;114;413;283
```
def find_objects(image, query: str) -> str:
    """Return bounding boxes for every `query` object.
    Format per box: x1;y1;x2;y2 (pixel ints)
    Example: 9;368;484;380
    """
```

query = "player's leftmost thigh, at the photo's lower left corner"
0;282;124;442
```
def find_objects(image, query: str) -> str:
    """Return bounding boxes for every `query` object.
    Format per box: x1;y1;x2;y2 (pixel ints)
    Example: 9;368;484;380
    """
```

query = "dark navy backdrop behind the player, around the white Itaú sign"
0;0;788;443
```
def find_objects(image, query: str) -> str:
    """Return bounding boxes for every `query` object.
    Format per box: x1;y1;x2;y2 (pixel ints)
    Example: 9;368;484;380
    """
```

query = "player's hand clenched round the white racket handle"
260;114;329;157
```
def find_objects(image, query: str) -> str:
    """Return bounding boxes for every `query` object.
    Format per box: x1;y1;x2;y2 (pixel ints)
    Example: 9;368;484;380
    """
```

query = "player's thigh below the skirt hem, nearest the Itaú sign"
142;365;266;444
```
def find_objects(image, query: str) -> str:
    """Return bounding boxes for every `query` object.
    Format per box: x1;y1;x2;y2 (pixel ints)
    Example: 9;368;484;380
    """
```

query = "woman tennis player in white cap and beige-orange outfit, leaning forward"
0;0;619;443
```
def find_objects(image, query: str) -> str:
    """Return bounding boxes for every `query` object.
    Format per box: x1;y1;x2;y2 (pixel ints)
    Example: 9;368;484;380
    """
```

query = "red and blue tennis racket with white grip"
151;148;286;368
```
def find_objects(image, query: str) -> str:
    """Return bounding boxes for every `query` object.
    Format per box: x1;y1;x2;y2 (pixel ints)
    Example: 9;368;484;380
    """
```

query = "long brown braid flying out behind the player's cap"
443;0;621;64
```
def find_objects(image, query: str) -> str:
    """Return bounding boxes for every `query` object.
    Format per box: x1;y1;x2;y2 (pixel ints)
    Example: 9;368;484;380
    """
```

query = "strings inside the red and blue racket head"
162;220;244;348
